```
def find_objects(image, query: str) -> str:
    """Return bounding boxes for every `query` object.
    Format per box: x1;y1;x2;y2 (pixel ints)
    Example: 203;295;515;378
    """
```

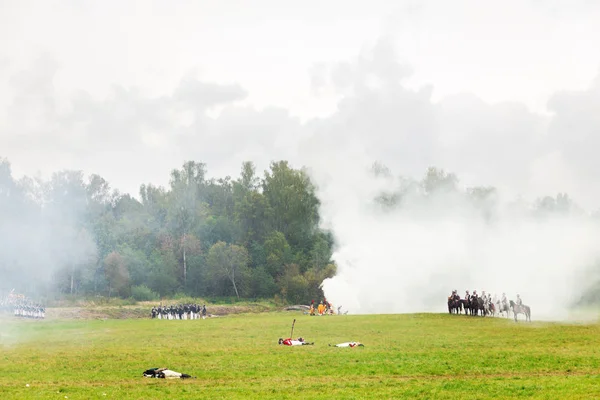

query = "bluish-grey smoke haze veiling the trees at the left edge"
0;165;98;294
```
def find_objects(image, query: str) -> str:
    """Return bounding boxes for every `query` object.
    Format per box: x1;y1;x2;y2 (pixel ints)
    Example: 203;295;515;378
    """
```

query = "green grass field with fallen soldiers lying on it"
0;312;600;399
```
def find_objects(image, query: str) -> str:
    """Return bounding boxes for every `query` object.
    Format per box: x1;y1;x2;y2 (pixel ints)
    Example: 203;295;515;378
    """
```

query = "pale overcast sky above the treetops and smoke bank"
0;0;600;208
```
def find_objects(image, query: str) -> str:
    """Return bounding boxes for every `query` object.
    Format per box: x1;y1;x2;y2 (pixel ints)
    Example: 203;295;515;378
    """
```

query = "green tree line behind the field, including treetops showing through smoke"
0;159;597;304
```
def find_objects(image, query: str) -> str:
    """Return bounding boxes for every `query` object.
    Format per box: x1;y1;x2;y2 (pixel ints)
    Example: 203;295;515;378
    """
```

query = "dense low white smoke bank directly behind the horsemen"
319;164;600;320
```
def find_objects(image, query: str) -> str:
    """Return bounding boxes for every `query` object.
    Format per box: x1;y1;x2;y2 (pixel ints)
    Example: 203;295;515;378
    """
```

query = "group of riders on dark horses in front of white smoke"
448;290;531;321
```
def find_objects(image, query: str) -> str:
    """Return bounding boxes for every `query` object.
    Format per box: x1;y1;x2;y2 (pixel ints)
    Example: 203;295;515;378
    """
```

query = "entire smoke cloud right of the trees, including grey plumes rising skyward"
305;41;600;319
